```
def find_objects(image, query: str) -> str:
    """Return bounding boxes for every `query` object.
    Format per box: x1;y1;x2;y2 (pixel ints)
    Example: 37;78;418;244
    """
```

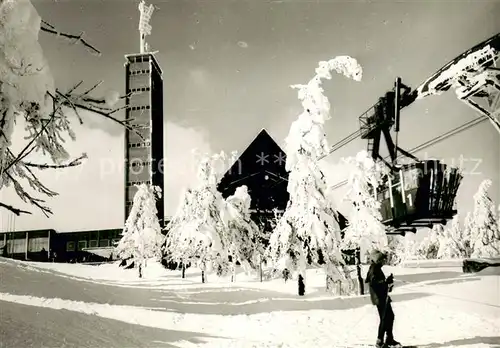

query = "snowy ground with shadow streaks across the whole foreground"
0;258;500;348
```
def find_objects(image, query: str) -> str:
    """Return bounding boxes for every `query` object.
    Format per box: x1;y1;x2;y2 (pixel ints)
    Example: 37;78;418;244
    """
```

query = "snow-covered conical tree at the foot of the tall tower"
115;184;165;278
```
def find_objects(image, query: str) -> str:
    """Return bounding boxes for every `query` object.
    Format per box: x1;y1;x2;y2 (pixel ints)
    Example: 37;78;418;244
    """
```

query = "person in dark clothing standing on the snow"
365;250;401;348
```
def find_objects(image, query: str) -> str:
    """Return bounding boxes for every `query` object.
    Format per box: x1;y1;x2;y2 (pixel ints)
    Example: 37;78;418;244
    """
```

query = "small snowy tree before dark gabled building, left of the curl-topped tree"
222;185;262;281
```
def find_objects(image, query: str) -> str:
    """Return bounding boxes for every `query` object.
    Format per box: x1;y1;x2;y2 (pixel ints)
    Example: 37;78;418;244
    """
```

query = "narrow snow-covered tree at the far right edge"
468;179;500;257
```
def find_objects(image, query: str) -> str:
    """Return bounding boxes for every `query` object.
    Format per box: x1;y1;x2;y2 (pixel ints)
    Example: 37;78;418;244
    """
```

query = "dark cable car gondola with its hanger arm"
359;78;462;234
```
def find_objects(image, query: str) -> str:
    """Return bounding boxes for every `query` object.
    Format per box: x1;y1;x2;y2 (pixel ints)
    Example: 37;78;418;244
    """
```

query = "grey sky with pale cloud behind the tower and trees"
2;0;500;231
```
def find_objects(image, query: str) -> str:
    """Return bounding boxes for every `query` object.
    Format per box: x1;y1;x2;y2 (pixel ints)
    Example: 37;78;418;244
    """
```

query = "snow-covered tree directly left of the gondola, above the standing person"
342;150;388;253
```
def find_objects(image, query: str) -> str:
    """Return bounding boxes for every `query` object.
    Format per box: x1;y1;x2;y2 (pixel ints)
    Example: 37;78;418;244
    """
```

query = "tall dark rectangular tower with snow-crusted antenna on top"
125;1;164;226
